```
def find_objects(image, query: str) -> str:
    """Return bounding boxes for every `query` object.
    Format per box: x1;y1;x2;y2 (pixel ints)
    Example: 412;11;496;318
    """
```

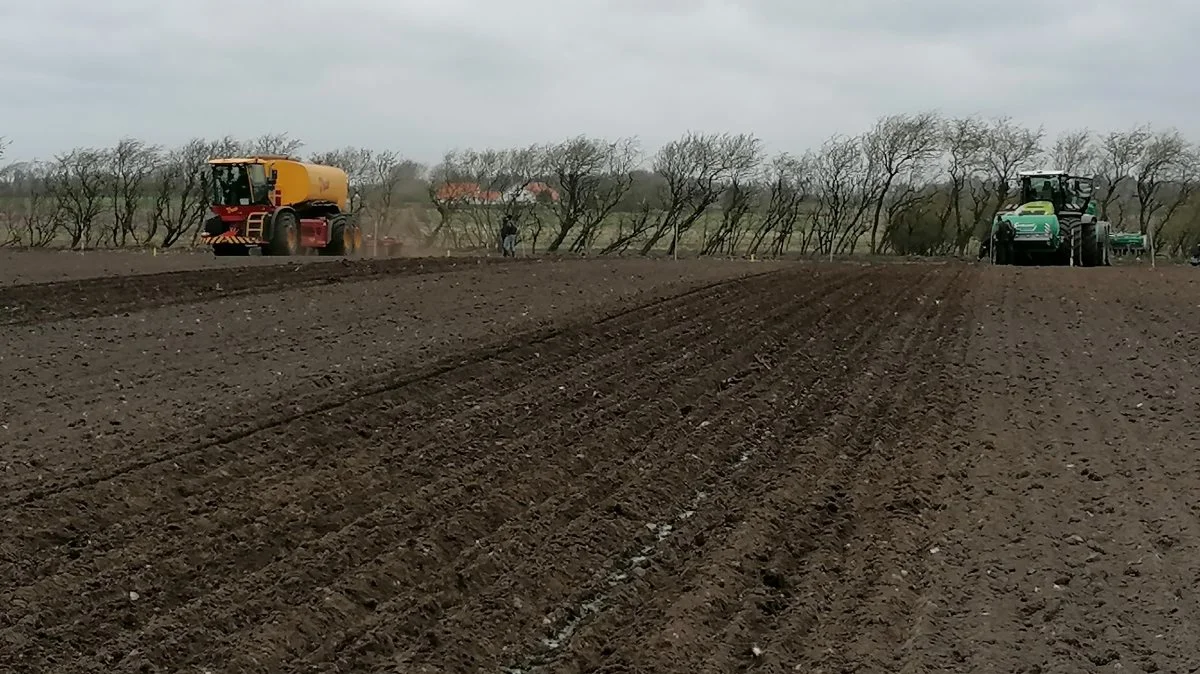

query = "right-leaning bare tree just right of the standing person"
544;136;641;252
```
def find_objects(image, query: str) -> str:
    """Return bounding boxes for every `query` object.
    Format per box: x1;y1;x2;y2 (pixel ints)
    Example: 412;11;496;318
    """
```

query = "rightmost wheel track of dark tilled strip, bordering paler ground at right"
753;269;977;672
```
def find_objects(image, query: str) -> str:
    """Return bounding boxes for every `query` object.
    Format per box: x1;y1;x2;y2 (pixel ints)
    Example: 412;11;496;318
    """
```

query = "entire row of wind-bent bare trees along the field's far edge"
0;113;1200;255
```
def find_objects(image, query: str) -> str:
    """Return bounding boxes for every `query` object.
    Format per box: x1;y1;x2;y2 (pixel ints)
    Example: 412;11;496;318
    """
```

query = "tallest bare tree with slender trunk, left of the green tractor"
863;112;941;254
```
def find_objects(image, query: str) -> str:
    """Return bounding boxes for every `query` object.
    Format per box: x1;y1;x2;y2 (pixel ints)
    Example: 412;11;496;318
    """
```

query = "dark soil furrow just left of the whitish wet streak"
297;266;883;667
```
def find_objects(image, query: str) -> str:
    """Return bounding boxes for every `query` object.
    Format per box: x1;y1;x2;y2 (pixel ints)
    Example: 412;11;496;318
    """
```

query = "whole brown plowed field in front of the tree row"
0;260;1200;673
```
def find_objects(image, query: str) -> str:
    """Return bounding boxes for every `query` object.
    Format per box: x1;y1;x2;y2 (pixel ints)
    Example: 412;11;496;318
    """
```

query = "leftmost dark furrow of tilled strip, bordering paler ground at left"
0;267;753;572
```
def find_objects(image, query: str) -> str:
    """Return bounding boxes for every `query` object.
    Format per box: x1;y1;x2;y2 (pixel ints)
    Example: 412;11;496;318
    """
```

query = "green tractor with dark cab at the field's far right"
979;170;1112;266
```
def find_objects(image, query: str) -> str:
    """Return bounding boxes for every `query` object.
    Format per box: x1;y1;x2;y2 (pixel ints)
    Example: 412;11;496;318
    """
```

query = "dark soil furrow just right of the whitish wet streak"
513;265;955;670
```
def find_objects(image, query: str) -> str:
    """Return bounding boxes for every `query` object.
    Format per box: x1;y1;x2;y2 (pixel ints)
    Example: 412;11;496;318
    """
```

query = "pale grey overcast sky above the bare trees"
0;0;1200;162
